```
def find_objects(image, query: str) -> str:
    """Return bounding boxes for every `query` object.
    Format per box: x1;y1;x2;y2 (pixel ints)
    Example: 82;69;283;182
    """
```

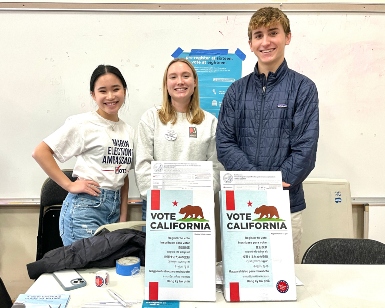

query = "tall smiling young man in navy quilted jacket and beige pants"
216;7;319;263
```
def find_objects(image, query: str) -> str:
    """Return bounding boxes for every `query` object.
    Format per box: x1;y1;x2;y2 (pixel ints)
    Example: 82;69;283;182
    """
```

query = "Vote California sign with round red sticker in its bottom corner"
220;190;297;302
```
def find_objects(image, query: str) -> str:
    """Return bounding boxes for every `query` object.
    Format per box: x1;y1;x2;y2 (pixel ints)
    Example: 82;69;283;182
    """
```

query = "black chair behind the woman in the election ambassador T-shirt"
36;169;76;261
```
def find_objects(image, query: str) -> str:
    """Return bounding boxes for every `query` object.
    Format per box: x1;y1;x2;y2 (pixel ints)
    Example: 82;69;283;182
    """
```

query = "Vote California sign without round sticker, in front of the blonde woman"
145;190;216;301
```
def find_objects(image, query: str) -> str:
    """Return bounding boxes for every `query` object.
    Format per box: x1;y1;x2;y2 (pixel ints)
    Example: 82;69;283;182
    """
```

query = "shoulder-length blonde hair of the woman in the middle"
158;58;205;124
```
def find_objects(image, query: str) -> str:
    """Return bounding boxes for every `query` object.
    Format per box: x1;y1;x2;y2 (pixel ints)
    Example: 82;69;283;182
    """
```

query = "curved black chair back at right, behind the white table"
302;238;385;264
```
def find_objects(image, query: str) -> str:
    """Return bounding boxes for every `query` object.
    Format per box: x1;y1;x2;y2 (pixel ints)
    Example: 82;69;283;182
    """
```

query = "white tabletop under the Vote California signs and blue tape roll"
27;264;385;308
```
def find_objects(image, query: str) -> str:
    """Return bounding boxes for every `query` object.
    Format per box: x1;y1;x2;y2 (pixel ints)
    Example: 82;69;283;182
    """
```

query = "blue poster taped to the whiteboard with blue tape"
172;48;246;118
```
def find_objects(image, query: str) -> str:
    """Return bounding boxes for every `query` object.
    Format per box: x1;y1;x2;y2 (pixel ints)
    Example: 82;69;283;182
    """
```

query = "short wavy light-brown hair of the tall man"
248;7;291;40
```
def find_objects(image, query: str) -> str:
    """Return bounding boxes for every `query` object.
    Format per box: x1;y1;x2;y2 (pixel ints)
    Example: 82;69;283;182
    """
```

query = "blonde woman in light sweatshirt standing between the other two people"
135;58;223;220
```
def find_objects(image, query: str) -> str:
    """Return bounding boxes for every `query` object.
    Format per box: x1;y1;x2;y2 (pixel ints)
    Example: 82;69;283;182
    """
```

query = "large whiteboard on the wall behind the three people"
0;11;385;198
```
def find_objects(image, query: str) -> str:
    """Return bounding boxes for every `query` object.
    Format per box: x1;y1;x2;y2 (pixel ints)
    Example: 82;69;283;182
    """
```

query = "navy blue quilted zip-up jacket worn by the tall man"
216;60;319;213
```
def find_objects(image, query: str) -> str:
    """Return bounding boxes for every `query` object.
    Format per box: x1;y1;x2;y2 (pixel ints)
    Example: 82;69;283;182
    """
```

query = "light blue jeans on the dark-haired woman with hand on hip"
59;189;121;246
